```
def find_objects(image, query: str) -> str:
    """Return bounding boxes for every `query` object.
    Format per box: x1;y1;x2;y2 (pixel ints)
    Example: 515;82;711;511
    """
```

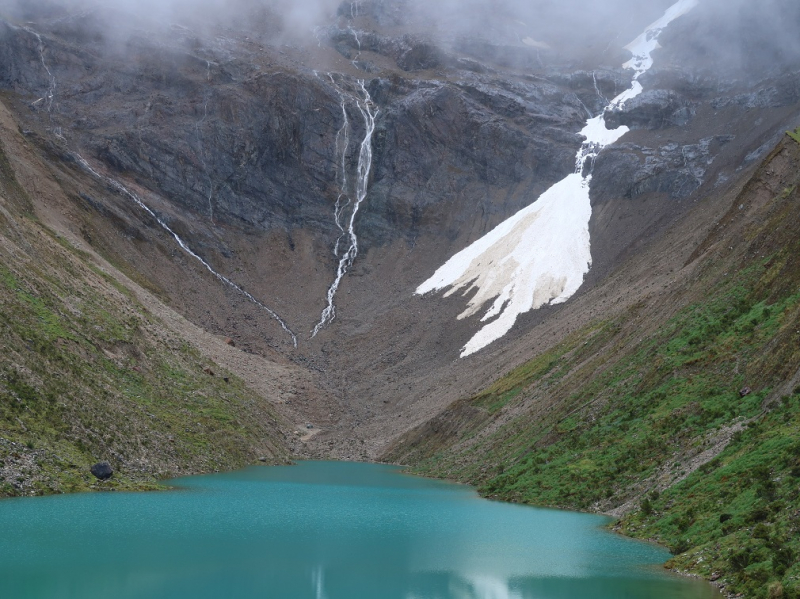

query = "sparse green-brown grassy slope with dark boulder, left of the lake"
0;119;288;497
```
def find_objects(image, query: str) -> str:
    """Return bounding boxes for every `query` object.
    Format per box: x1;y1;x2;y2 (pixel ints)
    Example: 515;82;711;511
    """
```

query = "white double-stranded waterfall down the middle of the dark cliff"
311;77;379;338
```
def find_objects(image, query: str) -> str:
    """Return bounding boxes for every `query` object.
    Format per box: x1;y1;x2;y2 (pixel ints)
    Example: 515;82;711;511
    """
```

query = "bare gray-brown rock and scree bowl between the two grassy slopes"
0;0;800;474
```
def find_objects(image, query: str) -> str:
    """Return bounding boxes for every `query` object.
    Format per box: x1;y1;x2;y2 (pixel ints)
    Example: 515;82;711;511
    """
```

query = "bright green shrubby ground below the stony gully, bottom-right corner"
622;389;800;598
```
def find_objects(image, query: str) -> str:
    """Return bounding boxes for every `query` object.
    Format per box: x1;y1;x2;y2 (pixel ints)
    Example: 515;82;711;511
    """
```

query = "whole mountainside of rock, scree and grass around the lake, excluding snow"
0;0;800;593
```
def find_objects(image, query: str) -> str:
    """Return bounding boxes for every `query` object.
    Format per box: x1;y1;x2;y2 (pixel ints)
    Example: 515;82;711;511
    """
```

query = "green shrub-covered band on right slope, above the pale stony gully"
410;274;800;509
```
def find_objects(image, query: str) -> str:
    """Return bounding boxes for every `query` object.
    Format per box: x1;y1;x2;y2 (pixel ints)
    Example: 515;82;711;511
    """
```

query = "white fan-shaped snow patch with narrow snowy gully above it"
416;0;698;357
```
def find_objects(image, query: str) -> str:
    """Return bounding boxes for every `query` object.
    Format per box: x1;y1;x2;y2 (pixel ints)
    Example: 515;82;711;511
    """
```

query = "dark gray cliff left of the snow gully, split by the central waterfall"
0;10;594;253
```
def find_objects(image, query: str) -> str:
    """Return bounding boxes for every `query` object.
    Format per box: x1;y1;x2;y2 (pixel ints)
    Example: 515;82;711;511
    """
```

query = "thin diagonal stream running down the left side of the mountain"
19;25;297;347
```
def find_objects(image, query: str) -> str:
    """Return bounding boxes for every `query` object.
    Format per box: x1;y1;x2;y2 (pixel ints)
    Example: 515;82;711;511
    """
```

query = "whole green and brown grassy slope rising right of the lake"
386;138;800;597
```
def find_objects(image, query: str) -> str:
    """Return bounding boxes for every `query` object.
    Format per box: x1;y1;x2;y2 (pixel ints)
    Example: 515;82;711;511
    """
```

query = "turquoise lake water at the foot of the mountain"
0;462;720;599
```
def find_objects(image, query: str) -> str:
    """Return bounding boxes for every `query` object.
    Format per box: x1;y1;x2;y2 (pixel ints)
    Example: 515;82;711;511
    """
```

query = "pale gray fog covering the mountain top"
0;0;800;73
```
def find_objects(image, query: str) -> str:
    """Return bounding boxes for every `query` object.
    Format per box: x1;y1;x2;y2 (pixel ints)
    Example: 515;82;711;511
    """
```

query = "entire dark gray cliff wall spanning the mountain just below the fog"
0;0;800;366
